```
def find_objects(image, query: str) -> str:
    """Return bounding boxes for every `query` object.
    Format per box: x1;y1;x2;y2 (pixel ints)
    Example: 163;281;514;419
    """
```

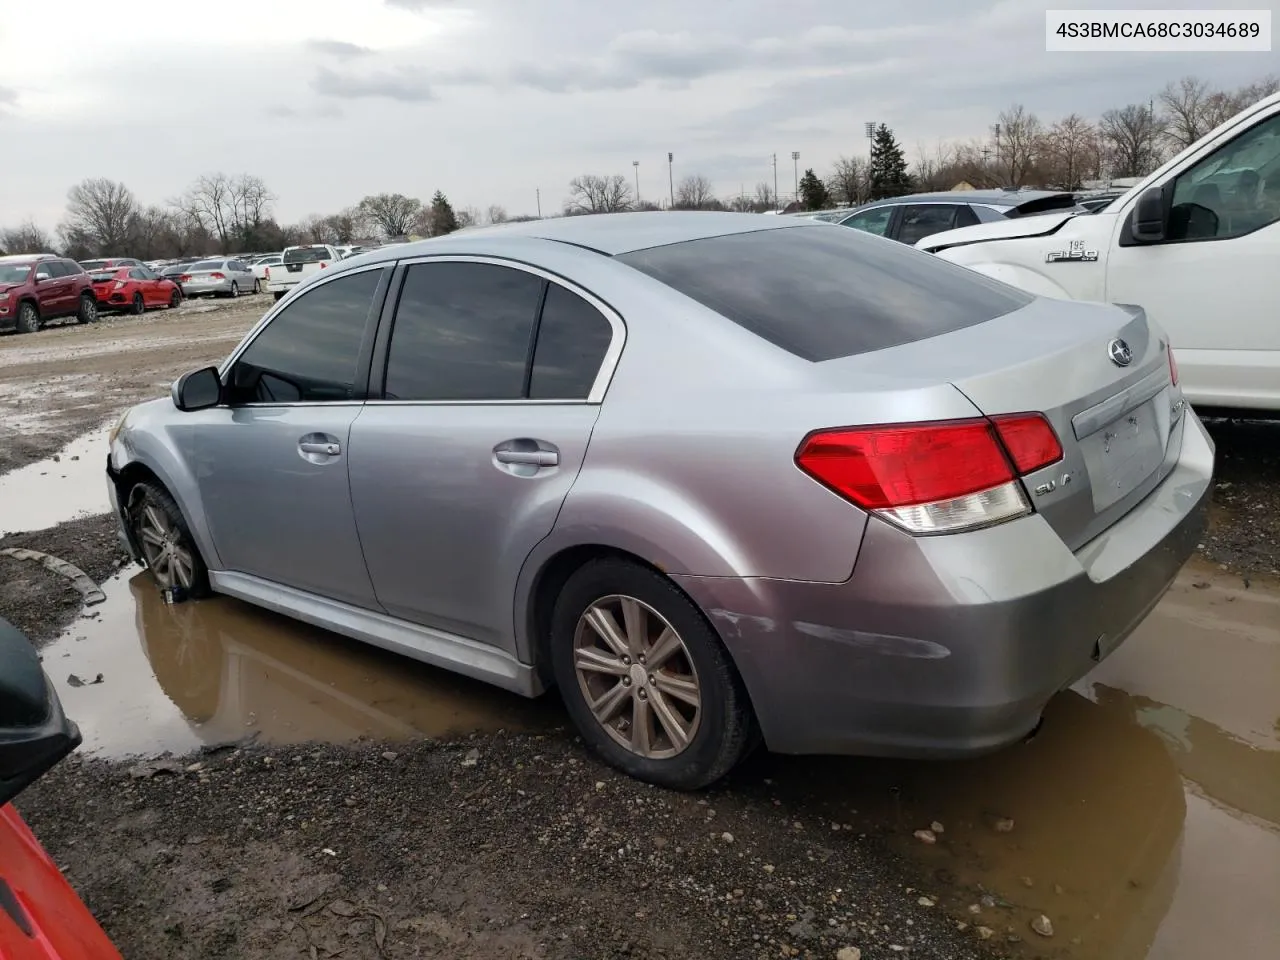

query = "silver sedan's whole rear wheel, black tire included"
550;558;755;790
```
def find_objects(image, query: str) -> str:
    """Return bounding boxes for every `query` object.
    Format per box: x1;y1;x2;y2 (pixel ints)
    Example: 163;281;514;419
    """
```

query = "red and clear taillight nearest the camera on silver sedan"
796;413;1062;534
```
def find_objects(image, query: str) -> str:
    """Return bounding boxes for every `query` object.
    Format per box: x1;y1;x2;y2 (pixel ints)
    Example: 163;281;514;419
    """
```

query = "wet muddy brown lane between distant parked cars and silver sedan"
0;294;263;473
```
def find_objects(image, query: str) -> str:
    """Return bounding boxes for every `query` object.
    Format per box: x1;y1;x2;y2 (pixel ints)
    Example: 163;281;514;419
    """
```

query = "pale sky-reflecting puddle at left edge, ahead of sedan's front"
0;426;111;536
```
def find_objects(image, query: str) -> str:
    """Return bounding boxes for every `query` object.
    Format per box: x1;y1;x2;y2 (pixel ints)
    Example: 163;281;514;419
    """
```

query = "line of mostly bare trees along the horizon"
0;76;1280;260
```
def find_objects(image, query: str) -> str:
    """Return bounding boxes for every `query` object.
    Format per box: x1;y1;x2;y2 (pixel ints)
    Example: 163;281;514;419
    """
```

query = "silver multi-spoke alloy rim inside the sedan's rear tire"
573;595;703;760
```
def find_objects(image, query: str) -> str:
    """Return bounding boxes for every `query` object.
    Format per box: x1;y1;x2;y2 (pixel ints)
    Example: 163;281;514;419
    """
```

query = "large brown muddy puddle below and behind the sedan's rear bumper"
747;564;1280;960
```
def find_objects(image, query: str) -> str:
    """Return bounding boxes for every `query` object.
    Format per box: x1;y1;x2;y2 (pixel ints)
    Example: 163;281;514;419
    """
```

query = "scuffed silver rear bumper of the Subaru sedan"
675;411;1213;756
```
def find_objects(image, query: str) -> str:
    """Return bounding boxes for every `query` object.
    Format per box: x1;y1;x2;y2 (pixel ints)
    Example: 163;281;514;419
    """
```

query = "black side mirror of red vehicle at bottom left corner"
0;618;81;806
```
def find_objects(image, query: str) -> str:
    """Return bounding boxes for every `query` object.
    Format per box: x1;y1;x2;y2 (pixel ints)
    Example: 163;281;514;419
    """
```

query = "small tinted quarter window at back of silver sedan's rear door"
529;283;613;399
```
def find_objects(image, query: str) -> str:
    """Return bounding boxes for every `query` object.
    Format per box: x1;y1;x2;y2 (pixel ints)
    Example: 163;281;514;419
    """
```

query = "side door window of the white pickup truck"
1167;114;1280;241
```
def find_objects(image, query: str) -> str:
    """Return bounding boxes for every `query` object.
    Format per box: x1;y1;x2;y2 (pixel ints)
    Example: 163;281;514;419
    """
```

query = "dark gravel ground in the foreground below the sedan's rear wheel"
19;733;986;960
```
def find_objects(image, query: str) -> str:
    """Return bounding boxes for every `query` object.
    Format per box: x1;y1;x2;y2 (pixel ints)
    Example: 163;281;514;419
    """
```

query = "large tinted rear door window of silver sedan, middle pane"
385;262;543;401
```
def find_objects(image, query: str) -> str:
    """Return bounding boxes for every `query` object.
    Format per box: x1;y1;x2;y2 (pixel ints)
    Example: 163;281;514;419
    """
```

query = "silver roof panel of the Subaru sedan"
373;211;813;256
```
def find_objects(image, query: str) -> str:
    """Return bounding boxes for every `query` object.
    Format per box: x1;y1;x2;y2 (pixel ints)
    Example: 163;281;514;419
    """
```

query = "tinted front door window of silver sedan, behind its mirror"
230;270;381;403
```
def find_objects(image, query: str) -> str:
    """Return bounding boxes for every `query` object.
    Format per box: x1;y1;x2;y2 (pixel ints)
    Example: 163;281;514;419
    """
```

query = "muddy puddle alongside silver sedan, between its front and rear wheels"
44;572;563;756
